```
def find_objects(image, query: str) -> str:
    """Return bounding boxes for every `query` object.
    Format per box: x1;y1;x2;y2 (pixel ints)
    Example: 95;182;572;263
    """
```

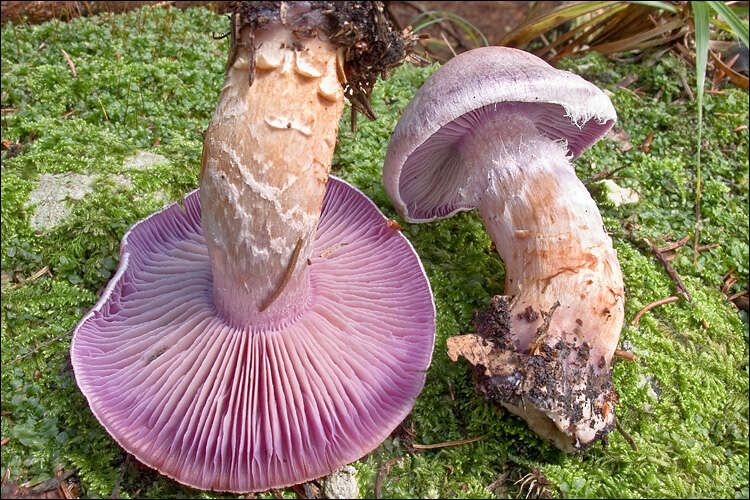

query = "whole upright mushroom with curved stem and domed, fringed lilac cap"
383;47;624;452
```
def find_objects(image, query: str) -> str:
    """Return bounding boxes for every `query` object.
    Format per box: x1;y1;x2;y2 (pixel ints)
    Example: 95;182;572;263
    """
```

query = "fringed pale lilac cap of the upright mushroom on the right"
383;47;617;222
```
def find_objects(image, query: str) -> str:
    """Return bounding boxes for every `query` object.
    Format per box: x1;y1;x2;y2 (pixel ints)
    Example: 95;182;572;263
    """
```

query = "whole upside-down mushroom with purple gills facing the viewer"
71;2;435;493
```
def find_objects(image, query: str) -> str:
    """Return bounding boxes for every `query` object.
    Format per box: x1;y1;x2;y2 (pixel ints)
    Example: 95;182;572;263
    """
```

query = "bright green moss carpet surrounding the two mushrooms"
0;4;748;498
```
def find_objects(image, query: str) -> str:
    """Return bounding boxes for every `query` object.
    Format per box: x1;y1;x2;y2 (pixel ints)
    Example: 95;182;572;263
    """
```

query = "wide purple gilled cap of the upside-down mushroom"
71;177;435;492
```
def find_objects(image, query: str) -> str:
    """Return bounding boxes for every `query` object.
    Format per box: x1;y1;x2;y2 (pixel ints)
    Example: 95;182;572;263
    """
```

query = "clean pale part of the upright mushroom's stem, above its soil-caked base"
467;115;624;368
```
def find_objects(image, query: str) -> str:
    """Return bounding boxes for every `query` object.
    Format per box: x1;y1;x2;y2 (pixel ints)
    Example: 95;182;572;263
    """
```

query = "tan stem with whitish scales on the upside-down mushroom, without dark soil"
200;24;344;329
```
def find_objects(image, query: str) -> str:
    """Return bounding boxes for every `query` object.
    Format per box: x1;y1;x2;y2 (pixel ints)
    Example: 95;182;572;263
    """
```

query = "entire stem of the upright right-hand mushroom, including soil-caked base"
470;114;624;451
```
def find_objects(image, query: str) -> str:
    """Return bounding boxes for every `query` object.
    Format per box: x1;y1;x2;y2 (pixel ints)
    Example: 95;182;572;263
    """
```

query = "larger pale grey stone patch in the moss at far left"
27;173;95;230
